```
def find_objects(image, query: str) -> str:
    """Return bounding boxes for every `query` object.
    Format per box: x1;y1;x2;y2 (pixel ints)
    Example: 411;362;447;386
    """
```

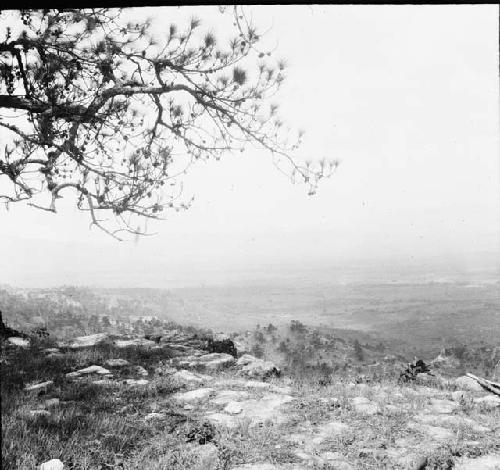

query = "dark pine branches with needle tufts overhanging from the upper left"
0;7;337;236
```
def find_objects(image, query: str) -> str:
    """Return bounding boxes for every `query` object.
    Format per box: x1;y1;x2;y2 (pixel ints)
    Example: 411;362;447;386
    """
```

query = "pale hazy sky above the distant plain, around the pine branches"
0;5;500;287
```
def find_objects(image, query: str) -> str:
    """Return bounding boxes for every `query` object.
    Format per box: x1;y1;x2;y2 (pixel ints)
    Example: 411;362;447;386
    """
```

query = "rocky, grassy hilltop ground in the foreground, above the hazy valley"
2;330;500;470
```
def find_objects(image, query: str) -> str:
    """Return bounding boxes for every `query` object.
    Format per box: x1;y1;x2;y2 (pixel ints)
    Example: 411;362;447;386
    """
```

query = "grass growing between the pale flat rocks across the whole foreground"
1;332;500;470
